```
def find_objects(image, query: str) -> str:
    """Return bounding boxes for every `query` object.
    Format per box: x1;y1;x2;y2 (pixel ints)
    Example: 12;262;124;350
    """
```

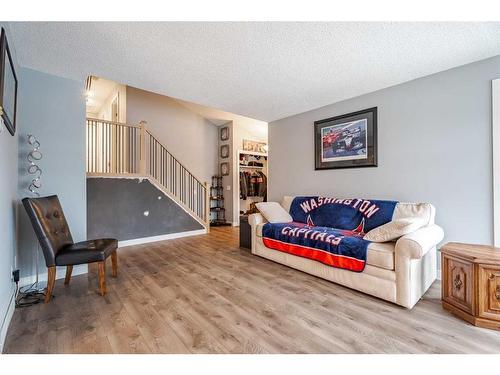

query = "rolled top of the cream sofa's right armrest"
395;224;444;259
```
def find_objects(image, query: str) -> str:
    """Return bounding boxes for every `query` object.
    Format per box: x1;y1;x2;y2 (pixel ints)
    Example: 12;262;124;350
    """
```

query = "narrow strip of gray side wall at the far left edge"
0;22;21;347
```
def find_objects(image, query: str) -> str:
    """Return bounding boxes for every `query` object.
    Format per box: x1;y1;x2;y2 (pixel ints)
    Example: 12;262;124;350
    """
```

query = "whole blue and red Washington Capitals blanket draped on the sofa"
262;197;397;272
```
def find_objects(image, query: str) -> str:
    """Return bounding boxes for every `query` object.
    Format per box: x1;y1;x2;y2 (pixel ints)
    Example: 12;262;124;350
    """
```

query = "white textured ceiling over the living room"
6;22;500;121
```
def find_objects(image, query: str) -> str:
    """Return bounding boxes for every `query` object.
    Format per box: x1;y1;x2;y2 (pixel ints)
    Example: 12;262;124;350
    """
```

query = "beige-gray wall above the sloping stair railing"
127;86;217;183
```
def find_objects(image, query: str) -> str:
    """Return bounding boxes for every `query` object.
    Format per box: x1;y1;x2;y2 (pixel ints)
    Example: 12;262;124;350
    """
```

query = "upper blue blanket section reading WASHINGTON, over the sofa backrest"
290;196;398;233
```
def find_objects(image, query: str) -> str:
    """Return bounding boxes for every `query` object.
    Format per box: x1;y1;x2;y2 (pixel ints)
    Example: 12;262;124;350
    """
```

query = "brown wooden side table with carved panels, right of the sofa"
441;242;500;330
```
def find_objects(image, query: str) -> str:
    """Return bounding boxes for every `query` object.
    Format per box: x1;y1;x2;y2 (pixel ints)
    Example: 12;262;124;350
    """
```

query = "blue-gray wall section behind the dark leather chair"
18;68;87;277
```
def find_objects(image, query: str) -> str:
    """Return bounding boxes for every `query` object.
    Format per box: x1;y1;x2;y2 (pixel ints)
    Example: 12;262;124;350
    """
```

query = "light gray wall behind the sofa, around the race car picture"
269;56;500;244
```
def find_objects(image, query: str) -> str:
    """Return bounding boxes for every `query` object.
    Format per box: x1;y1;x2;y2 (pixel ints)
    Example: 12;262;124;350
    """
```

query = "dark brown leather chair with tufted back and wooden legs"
23;195;118;303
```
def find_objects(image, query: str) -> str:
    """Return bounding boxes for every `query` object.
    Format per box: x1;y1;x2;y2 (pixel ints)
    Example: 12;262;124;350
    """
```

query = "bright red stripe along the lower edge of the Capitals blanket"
262;237;365;272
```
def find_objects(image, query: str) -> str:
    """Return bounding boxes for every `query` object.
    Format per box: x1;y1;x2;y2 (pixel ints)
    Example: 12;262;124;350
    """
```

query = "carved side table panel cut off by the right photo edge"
478;264;500;321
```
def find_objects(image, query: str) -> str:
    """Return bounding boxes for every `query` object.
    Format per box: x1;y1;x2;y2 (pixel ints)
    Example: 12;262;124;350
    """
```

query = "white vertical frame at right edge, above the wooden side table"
491;79;500;247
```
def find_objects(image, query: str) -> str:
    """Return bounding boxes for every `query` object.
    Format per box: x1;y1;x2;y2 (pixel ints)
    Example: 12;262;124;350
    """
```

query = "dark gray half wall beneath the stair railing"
87;178;203;241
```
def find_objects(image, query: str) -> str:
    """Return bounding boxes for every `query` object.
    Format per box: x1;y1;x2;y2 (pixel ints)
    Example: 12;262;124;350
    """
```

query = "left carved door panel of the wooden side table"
442;256;474;314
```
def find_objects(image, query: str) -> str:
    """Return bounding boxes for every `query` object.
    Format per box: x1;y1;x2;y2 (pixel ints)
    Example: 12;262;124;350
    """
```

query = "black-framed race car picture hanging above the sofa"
314;107;377;170
